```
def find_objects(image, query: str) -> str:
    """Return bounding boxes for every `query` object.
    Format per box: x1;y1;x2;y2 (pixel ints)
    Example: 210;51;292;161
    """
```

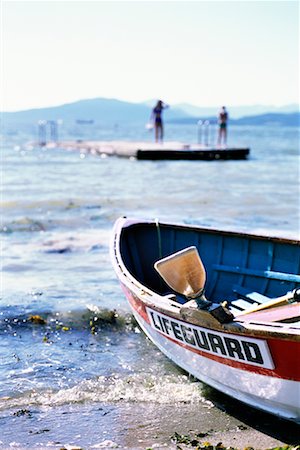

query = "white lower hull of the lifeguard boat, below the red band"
132;298;300;422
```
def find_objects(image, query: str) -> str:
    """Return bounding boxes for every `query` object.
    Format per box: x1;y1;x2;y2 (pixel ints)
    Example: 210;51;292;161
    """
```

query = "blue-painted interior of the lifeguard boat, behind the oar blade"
120;223;300;310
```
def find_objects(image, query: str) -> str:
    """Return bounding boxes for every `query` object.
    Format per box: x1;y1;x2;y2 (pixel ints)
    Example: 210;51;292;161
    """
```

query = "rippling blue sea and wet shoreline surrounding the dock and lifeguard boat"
0;121;300;449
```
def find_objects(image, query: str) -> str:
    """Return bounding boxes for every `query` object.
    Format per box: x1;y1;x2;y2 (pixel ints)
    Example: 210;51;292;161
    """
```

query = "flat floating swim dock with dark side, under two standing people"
47;140;250;161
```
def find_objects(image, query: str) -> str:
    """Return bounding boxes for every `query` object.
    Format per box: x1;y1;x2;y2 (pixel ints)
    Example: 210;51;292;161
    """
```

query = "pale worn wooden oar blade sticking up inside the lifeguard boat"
154;246;206;298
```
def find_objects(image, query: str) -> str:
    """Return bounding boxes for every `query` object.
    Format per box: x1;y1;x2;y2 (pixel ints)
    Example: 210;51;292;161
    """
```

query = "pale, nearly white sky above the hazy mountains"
0;0;299;111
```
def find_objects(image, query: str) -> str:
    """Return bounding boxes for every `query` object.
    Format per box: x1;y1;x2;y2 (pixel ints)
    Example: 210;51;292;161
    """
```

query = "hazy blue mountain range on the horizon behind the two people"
2;98;299;132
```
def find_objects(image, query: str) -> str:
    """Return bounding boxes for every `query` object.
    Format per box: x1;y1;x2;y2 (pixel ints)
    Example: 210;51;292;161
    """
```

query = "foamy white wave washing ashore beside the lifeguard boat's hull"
0;373;212;410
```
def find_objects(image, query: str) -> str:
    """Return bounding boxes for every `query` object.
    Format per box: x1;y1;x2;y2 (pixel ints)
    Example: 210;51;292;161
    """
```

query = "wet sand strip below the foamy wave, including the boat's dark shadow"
0;398;300;450
